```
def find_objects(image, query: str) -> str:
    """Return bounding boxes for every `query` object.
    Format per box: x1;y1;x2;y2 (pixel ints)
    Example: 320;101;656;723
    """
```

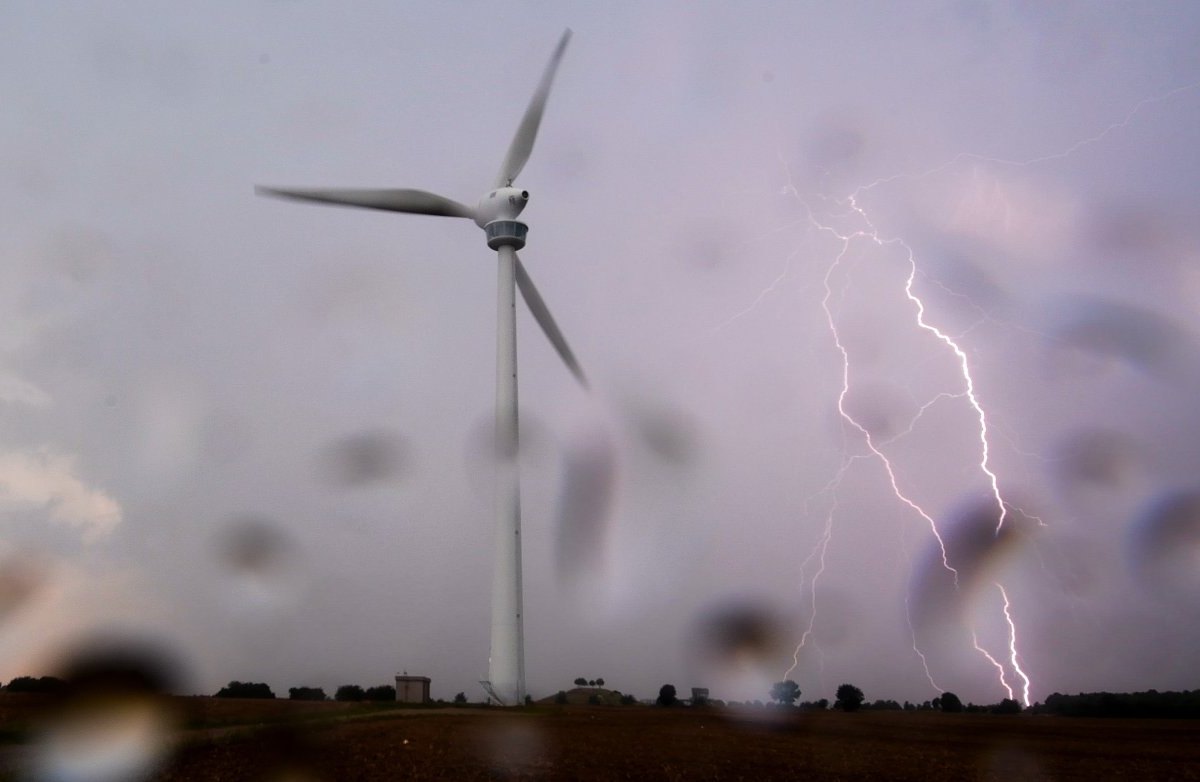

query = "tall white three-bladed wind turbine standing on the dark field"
254;30;587;705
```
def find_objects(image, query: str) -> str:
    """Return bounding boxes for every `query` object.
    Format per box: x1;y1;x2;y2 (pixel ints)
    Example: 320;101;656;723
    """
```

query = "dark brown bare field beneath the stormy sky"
0;698;1200;782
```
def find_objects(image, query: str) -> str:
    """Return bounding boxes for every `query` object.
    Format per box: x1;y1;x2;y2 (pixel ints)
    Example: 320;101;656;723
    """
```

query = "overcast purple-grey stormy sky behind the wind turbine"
0;0;1200;703
